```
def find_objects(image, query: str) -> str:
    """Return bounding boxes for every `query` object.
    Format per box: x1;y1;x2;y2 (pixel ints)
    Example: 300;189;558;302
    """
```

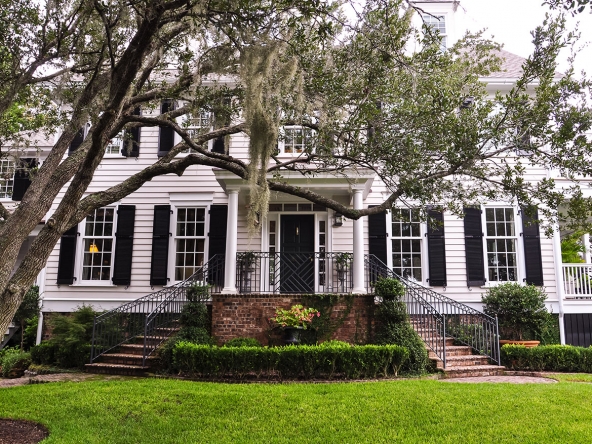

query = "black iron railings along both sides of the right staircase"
365;255;500;368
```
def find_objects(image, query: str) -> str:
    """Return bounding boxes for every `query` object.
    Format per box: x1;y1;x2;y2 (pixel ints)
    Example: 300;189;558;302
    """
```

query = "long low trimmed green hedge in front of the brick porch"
173;342;409;379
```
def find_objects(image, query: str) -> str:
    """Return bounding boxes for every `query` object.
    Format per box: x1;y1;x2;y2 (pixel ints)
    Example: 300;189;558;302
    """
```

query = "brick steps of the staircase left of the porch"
85;327;179;376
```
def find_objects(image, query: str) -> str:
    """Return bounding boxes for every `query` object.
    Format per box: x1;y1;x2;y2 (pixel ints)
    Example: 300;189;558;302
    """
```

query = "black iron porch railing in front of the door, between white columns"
236;251;353;293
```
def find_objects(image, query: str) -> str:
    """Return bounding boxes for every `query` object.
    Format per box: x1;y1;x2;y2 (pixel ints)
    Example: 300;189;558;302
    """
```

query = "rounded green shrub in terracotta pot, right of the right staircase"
482;282;551;347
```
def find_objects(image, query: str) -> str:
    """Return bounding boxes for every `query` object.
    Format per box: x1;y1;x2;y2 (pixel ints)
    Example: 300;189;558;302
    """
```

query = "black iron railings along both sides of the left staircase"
90;255;224;363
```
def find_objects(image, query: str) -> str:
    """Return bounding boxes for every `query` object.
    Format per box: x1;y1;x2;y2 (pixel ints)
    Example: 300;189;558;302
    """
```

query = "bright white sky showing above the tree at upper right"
456;0;592;75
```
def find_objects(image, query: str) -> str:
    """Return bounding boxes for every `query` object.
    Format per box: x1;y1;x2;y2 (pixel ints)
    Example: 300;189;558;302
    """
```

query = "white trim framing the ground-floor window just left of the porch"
165;193;213;287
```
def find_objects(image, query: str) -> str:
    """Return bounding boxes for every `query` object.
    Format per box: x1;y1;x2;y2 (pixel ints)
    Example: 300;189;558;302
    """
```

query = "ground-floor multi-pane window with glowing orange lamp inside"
81;207;115;283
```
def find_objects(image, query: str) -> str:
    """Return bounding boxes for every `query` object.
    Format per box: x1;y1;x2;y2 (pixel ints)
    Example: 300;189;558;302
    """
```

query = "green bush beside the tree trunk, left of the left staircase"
31;305;97;368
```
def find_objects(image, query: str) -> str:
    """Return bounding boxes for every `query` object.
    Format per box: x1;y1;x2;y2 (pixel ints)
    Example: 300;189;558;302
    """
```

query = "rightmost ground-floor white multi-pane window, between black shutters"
485;207;518;282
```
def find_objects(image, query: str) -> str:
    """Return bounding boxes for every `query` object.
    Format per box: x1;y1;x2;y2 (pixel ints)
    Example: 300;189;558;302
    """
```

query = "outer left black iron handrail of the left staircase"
90;255;224;364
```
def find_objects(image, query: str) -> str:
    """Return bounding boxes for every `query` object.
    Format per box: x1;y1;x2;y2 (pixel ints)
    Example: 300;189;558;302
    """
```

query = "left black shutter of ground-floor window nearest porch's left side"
150;205;171;285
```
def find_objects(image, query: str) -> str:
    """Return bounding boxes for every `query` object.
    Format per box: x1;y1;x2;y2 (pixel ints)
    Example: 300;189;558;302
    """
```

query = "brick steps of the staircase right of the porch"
411;321;505;378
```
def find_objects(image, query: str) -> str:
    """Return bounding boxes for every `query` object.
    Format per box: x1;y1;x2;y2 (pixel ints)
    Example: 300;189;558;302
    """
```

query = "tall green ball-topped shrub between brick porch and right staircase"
374;278;428;374
